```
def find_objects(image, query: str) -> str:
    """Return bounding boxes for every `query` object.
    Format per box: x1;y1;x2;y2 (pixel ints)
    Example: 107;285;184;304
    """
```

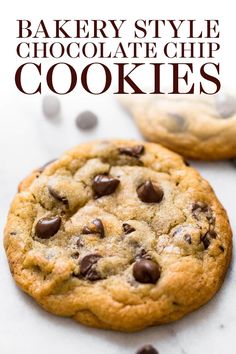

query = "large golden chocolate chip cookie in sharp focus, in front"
4;140;231;331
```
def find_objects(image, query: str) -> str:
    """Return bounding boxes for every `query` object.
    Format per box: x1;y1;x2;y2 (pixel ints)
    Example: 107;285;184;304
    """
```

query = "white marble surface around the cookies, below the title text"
0;94;236;354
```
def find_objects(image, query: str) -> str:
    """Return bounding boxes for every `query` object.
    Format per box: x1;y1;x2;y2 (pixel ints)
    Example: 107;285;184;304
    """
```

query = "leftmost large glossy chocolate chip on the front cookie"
35;216;61;239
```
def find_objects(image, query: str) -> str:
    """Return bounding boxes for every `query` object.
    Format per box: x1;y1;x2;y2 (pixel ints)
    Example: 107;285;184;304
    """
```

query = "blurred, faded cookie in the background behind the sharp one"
121;94;236;160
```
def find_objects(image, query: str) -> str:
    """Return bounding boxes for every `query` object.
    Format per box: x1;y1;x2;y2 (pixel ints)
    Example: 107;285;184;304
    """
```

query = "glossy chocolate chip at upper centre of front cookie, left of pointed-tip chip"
92;175;120;198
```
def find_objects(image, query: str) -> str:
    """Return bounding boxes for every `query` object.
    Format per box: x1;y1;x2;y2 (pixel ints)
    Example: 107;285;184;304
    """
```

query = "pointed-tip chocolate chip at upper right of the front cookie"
137;181;164;203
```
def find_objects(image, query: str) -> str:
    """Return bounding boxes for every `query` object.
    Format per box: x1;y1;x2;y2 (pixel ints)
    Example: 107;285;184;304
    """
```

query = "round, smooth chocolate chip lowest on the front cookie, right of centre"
133;259;161;284
